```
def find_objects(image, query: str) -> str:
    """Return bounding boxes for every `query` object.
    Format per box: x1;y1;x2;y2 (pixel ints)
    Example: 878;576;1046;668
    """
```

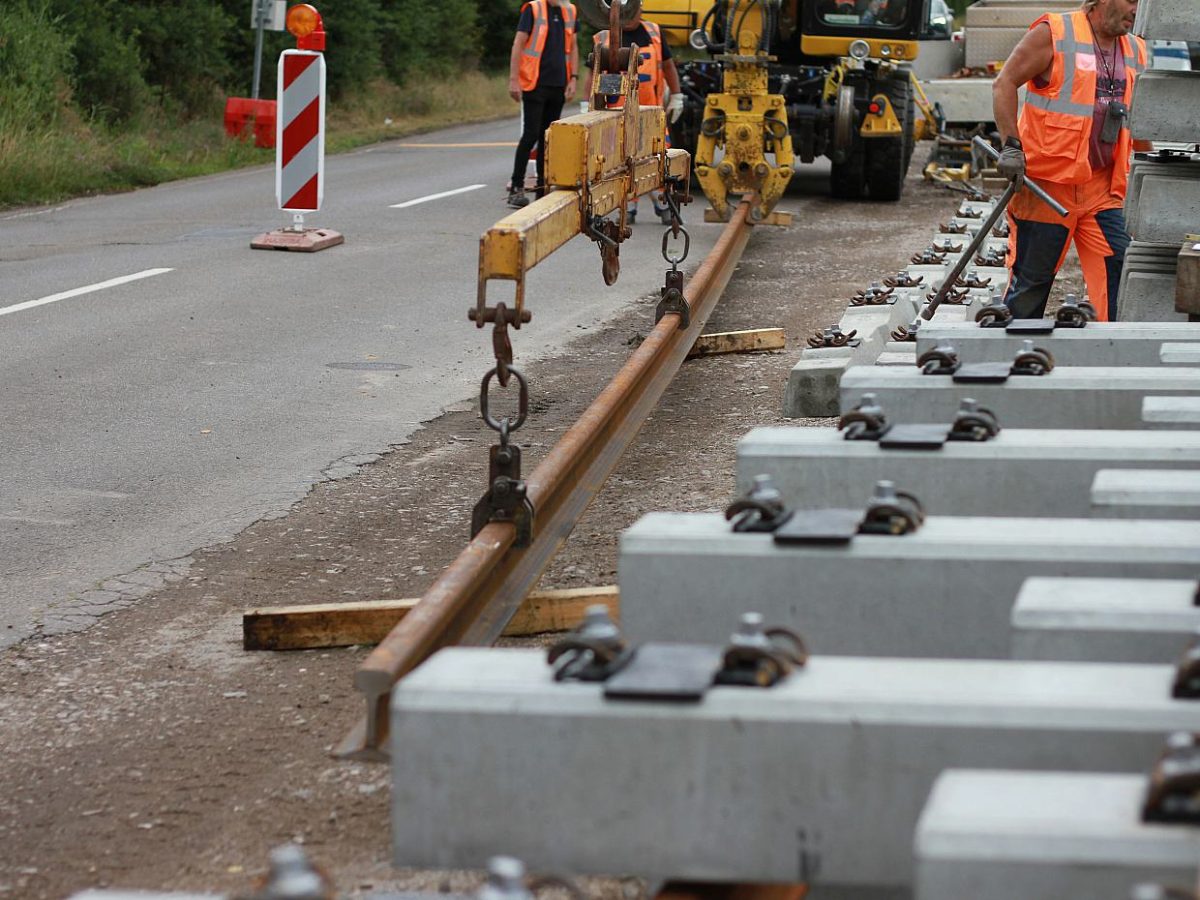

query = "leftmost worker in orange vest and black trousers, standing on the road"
509;0;580;209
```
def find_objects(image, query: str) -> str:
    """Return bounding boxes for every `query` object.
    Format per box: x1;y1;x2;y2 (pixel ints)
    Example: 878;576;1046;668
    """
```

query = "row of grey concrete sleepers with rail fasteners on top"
391;17;1200;900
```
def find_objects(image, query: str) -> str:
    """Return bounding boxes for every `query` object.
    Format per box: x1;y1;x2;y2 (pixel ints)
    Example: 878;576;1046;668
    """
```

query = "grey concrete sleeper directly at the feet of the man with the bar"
917;322;1200;367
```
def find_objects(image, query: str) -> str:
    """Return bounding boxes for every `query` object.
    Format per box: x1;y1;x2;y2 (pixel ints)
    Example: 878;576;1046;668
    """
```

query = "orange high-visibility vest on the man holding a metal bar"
1018;11;1146;197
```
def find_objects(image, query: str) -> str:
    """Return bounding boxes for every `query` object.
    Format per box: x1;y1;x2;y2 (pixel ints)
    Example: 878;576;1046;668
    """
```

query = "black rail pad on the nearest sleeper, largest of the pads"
604;643;721;703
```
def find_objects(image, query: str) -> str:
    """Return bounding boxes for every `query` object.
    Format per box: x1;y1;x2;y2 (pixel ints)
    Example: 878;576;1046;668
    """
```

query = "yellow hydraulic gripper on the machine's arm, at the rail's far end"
696;4;793;222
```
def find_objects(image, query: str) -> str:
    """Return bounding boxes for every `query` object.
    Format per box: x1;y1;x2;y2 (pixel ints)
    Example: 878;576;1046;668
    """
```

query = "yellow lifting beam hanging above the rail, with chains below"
470;47;691;328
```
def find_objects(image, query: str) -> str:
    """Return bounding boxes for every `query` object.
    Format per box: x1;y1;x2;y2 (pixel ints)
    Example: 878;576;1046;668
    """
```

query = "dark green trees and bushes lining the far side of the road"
0;0;530;124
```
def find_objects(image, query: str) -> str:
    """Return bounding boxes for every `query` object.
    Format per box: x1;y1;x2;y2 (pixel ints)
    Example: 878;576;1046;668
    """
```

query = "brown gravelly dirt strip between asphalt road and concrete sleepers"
0;167;1078;898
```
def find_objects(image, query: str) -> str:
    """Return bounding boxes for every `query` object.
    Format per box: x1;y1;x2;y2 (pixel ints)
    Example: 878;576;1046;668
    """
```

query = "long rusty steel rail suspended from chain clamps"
335;200;751;762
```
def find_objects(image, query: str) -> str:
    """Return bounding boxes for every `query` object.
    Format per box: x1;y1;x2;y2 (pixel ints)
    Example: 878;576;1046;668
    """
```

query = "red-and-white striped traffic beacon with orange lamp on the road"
250;4;346;252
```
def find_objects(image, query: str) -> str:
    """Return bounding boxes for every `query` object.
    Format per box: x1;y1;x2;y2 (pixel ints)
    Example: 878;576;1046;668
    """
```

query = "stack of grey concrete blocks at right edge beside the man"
1118;0;1200;322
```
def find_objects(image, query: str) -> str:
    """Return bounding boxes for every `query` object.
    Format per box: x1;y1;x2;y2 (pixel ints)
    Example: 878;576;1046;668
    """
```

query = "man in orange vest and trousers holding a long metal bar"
992;0;1147;320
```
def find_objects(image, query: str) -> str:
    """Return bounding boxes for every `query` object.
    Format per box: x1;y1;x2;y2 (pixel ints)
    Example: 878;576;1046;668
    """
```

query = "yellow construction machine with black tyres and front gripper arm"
580;0;929;218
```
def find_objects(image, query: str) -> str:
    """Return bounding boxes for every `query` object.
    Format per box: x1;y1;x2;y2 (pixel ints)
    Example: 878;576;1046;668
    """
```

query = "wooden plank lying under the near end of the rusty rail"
241;584;620;650
